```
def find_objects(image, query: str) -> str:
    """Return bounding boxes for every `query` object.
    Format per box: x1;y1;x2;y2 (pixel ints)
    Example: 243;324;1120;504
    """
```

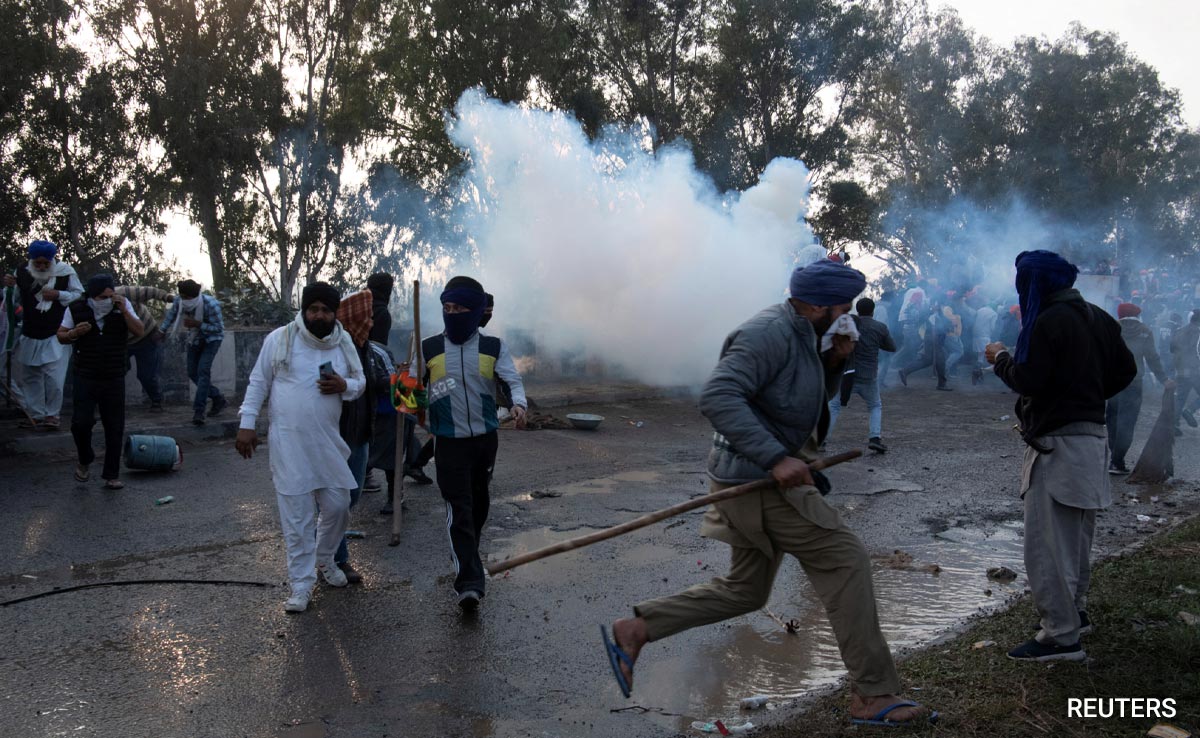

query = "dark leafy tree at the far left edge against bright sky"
0;0;163;277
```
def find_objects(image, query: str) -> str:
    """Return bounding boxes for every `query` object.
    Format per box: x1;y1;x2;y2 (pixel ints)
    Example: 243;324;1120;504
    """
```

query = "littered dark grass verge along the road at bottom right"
756;517;1200;738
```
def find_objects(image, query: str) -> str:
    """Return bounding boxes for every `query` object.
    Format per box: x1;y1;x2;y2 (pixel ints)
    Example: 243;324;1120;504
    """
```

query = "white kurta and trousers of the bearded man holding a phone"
239;326;366;595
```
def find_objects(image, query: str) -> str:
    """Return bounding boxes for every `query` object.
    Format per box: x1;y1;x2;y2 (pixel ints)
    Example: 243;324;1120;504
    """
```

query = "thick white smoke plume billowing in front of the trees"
441;91;823;386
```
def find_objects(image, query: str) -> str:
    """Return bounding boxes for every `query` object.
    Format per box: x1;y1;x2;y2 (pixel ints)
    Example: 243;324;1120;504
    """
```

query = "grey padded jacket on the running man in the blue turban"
700;302;841;484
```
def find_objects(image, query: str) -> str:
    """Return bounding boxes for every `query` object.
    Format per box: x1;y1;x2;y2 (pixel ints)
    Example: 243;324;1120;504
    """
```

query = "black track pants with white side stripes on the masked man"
433;431;499;594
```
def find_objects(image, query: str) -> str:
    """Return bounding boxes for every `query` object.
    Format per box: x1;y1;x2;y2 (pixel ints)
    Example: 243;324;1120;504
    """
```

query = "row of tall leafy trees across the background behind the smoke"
0;0;1200;294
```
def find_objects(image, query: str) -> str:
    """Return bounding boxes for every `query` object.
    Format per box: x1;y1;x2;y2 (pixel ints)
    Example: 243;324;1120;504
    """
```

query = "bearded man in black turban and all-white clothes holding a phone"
236;282;366;612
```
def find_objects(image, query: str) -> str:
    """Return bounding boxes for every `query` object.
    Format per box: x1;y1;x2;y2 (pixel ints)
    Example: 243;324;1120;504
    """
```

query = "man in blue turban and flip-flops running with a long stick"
605;260;936;725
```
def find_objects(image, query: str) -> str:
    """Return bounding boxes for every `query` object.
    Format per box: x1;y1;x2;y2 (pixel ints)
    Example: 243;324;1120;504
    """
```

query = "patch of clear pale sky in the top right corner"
945;0;1200;127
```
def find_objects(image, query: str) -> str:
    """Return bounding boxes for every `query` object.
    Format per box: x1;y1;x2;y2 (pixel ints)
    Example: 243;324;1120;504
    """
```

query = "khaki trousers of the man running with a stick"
634;485;900;697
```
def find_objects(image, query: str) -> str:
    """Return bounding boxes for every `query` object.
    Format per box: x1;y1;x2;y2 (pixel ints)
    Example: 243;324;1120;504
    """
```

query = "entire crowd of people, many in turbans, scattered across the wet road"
5;241;1200;725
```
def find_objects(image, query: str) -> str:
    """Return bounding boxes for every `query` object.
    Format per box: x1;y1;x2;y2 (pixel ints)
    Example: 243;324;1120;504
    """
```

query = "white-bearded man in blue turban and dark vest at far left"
4;241;83;431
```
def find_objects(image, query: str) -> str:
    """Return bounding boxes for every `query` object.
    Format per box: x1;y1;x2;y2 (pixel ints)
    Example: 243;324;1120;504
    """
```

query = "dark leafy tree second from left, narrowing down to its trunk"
95;0;282;289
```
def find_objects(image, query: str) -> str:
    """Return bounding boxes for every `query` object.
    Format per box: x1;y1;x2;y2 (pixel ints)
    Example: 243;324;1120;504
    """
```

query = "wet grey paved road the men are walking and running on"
0;380;1200;738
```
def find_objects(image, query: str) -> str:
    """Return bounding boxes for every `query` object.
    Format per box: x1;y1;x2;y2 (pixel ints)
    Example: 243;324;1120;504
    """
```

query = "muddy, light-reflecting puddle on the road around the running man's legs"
624;524;1025;734
